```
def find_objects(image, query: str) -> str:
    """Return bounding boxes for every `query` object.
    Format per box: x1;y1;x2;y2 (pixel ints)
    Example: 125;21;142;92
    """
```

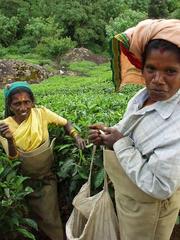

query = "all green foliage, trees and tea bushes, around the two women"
0;0;180;240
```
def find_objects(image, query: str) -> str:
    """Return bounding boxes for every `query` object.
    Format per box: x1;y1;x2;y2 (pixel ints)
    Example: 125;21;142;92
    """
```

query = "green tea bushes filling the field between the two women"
0;59;142;229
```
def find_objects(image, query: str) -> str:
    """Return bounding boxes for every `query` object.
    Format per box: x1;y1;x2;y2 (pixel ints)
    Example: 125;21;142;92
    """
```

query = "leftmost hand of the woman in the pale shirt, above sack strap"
88;124;105;145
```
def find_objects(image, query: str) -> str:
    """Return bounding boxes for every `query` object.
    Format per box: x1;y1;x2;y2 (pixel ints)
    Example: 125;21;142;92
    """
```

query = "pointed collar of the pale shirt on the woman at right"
133;88;180;119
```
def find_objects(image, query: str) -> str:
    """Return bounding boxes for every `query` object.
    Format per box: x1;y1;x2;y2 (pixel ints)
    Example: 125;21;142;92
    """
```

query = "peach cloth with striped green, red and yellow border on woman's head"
111;19;180;91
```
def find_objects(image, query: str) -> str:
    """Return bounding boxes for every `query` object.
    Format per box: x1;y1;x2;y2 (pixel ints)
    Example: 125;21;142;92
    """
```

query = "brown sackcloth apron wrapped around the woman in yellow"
19;139;63;240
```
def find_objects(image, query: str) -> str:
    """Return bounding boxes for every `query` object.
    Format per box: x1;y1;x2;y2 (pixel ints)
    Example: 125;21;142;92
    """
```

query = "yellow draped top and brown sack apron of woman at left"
0;107;67;240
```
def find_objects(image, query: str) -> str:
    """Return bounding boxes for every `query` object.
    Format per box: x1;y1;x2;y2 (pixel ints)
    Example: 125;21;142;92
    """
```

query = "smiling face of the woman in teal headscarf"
10;92;34;122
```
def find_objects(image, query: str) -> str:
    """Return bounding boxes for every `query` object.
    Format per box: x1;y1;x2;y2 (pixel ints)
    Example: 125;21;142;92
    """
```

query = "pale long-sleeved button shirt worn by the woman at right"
113;89;180;199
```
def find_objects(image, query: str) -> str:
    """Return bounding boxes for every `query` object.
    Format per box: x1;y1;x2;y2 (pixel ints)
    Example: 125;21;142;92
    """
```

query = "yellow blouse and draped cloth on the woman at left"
0;107;67;153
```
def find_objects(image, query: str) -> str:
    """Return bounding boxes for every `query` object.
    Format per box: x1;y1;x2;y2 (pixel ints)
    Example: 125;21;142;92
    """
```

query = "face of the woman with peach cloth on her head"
143;49;180;103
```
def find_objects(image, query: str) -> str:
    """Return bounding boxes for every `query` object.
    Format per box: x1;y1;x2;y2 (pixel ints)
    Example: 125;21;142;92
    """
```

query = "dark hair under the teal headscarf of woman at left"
5;87;35;118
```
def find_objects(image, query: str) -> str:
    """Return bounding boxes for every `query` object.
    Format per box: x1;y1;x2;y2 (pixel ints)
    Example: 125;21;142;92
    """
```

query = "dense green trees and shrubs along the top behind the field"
0;0;180;58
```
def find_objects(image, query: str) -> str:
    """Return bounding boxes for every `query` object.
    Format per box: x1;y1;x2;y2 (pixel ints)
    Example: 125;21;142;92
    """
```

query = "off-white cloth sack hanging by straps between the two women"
66;146;120;240
